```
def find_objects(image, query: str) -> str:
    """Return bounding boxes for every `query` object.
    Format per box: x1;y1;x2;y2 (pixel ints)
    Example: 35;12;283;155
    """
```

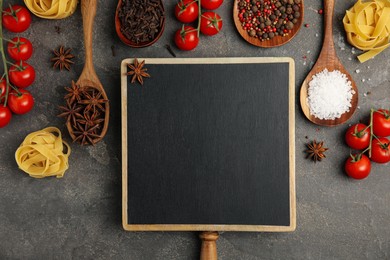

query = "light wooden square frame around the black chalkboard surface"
121;57;296;232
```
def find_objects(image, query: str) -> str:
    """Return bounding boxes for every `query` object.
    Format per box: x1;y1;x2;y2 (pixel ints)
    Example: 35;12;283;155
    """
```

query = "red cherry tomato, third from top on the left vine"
8;61;35;88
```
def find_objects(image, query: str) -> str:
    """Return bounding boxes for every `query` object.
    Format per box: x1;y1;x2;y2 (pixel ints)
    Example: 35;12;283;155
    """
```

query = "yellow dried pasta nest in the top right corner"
343;0;390;62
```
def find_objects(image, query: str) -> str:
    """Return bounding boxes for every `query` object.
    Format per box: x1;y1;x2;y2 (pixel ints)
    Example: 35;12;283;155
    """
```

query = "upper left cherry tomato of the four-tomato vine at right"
345;124;371;150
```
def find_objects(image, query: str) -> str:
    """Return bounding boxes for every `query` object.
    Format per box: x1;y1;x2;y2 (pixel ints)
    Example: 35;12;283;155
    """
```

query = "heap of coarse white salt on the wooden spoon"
306;69;355;120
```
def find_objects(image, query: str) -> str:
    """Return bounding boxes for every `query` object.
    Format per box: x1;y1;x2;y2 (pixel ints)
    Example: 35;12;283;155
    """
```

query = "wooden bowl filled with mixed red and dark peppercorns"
233;0;304;48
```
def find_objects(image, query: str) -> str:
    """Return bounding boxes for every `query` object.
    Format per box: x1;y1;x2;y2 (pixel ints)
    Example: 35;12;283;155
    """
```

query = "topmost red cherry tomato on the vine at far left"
2;5;31;32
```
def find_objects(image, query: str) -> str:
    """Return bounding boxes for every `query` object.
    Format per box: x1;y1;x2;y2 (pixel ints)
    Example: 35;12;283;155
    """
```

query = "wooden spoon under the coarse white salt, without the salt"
300;0;358;126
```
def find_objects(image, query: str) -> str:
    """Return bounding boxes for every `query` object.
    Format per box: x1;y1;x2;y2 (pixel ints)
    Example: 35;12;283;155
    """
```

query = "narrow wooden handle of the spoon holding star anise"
81;0;97;75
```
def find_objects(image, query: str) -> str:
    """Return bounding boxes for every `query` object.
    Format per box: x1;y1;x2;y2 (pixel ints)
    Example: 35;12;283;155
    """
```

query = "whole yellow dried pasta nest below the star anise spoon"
15;127;71;178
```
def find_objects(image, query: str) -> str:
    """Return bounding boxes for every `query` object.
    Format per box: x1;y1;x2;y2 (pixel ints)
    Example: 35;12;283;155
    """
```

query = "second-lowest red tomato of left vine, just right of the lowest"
8;89;34;115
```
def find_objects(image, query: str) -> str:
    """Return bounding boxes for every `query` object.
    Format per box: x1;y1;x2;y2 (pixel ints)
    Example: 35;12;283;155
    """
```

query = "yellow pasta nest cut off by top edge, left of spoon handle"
24;0;77;19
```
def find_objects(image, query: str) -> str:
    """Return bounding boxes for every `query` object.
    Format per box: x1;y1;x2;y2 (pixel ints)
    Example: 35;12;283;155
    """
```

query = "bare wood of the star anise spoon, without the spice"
66;0;110;143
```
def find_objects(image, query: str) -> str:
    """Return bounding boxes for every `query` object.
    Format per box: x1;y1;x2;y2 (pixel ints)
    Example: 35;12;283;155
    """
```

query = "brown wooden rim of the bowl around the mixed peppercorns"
233;0;304;48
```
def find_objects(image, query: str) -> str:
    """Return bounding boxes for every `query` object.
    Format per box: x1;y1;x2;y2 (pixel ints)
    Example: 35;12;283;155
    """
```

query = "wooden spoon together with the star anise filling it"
66;0;110;145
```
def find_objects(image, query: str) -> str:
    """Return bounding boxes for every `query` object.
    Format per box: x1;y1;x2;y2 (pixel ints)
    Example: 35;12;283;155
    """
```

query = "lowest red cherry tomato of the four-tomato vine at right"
344;154;371;180
